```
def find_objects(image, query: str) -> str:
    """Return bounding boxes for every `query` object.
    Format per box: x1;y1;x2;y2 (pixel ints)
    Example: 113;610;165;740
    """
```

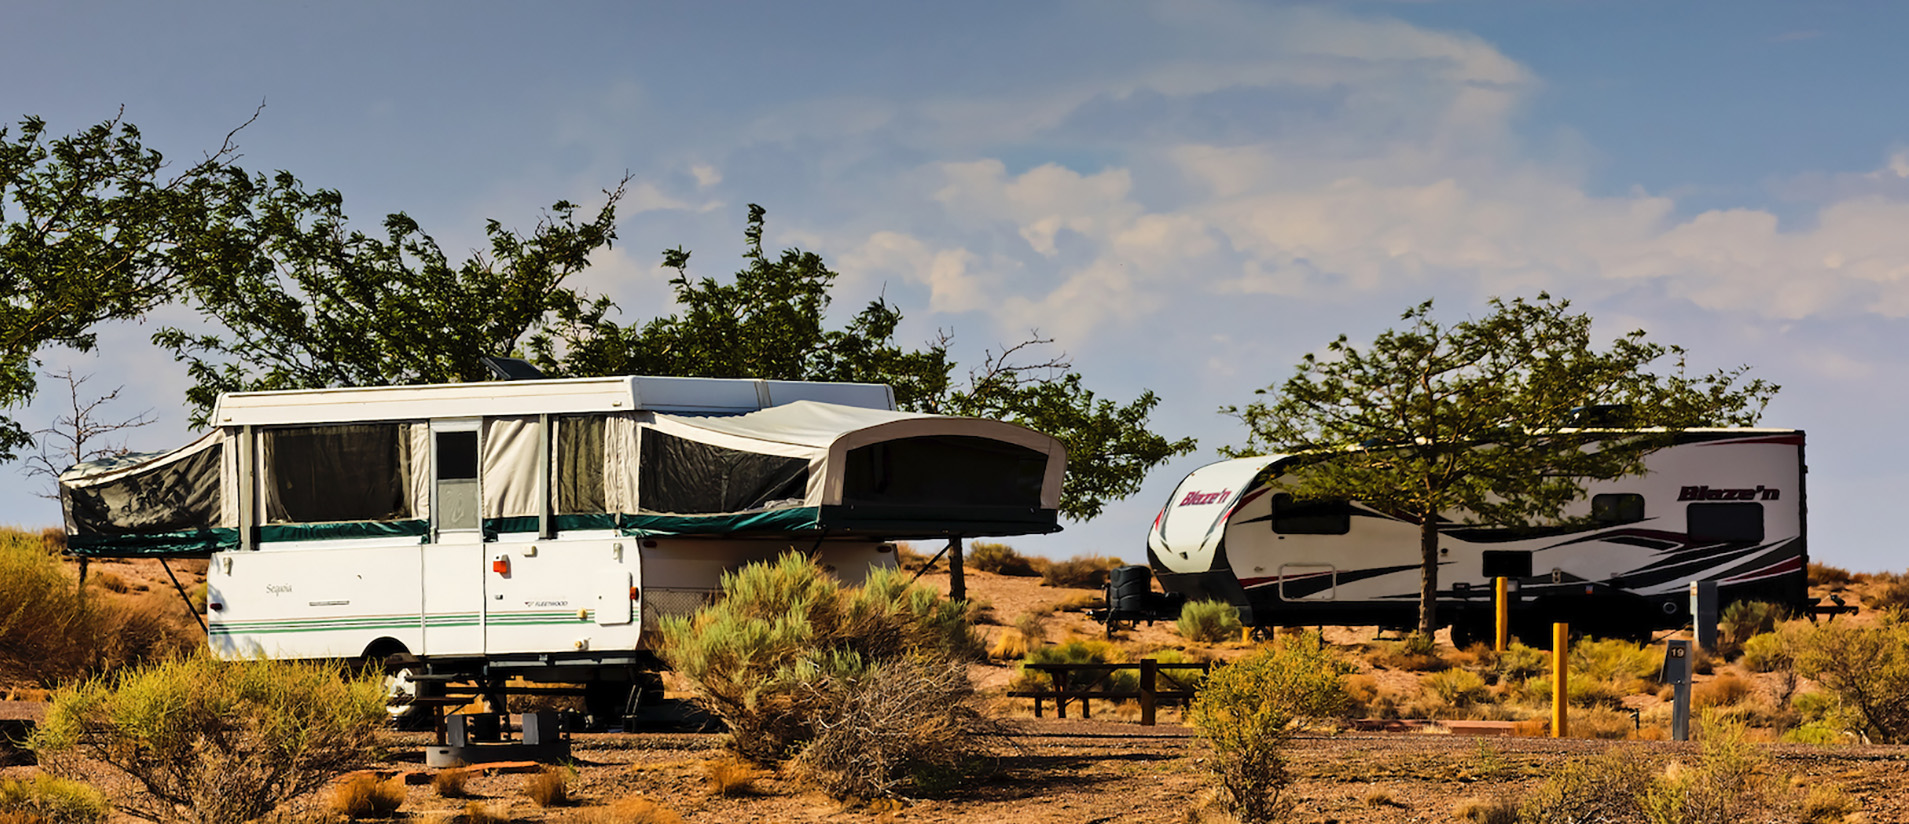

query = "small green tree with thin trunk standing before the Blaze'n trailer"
1222;294;1777;635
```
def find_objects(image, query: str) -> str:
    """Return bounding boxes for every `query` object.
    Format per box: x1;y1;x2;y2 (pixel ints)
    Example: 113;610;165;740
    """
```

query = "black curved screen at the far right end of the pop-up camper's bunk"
842;435;1048;507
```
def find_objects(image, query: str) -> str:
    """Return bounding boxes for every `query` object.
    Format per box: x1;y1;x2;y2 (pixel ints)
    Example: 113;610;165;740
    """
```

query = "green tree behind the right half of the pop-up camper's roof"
531;204;1193;521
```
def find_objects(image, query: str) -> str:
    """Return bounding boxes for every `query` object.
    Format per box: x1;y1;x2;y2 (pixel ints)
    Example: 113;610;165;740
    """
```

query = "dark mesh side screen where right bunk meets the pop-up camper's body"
636;429;809;515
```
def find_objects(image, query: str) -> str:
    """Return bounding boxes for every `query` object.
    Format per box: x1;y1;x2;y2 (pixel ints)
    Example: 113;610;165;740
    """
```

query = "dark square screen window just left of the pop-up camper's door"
260;423;410;523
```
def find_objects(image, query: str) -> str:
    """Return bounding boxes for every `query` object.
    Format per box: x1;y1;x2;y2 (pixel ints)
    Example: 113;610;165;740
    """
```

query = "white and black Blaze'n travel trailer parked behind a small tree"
1147;429;1808;645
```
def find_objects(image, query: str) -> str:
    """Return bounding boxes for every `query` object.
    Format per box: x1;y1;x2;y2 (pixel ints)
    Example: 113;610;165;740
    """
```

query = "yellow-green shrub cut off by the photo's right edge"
1794;616;1909;744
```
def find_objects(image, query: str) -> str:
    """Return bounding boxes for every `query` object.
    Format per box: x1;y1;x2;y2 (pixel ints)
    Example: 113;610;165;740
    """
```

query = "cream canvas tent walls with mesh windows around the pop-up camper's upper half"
61;401;1065;555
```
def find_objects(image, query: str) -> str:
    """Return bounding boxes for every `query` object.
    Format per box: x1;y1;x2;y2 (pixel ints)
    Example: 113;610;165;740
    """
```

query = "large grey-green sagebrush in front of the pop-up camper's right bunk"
662;553;985;763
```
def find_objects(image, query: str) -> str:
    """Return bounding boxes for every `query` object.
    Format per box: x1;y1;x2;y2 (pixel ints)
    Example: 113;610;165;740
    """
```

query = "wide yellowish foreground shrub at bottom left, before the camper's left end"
31;652;386;822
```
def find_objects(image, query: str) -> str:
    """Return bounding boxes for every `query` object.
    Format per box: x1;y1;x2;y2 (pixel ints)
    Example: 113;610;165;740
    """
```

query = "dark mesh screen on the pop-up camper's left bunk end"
67;446;223;536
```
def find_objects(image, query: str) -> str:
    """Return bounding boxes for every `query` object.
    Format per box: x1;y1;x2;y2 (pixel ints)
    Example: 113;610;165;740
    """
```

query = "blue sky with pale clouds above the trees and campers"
0;2;1909;568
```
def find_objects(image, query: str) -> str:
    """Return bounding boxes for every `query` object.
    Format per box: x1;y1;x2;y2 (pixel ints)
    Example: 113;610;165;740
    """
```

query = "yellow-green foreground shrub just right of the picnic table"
1185;637;1352;822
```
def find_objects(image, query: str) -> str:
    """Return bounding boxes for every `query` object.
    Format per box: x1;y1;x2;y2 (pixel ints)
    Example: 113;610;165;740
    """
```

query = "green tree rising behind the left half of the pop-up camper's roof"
153;172;622;425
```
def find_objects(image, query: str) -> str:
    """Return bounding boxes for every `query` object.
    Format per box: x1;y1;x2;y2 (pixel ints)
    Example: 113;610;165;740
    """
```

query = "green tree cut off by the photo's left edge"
0;109;250;460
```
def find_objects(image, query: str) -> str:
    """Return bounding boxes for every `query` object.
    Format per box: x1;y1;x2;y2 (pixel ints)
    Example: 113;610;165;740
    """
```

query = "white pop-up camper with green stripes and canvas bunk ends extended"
61;378;1065;715
